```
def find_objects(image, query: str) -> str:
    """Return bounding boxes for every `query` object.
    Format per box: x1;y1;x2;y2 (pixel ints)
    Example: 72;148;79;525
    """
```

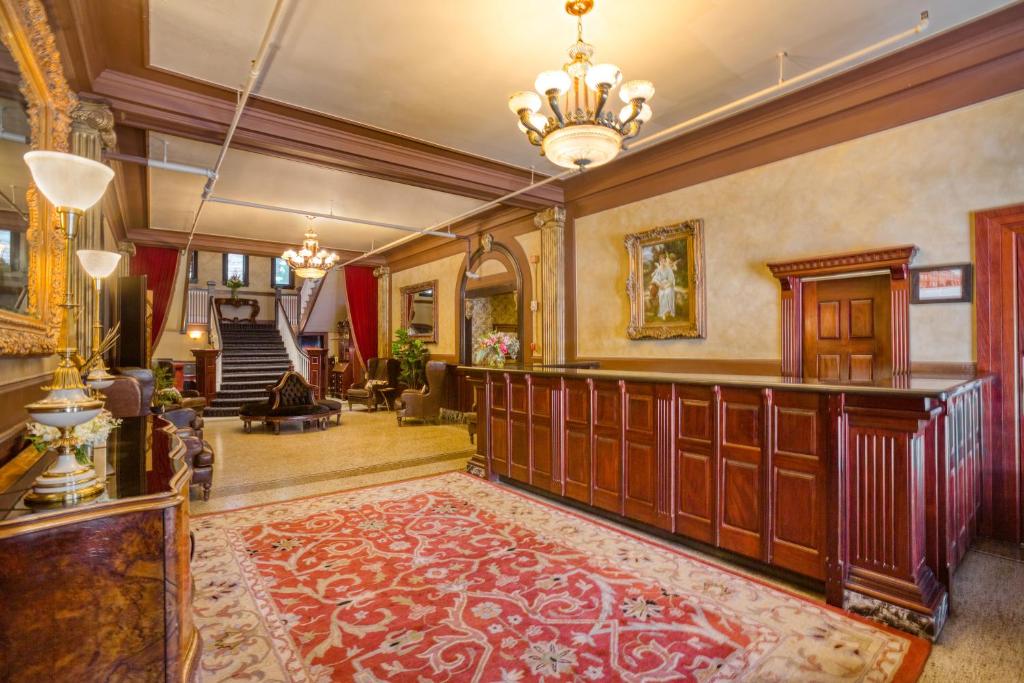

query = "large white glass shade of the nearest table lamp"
25;152;114;211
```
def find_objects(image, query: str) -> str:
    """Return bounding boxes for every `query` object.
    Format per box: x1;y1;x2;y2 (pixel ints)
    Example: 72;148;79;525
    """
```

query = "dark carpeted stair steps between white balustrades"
204;322;291;418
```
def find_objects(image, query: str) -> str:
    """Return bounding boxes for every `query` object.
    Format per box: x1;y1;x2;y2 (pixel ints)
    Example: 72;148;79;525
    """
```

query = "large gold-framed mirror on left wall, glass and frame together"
0;0;76;355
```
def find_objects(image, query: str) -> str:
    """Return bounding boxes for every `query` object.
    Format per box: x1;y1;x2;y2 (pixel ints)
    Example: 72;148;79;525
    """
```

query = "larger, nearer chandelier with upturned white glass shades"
509;0;654;169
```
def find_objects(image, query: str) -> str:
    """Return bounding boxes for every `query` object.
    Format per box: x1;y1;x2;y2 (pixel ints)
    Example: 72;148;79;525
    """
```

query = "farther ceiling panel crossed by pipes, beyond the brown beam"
148;132;480;251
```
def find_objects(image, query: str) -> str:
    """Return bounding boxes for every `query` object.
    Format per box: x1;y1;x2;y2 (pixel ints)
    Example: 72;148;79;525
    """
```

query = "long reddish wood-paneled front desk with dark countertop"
459;367;988;637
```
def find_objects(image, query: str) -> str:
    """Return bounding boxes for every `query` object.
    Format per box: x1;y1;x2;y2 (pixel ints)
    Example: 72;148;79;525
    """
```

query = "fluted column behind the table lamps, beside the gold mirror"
70;100;118;358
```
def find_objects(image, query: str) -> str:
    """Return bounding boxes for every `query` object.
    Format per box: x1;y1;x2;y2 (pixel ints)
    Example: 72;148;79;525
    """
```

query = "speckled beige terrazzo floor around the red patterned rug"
191;411;1024;683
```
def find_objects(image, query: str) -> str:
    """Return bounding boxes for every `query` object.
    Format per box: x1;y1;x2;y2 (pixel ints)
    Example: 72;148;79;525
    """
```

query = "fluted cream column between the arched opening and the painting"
534;207;565;362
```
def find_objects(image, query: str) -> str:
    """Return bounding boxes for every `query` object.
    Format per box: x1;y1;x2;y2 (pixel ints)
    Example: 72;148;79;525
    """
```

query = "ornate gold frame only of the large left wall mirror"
0;0;77;355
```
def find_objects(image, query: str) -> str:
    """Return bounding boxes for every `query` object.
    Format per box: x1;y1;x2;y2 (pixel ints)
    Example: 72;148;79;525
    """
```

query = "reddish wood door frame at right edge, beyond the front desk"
972;205;1024;543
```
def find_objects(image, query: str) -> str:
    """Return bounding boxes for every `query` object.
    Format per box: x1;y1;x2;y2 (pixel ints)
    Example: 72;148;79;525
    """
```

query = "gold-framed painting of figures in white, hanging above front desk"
626;219;707;339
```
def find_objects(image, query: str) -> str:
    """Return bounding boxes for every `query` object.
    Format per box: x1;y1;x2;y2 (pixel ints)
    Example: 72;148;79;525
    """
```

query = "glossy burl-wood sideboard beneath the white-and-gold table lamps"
0;416;201;682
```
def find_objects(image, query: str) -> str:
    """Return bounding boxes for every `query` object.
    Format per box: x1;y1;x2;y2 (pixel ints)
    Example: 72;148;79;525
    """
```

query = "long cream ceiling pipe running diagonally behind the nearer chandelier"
339;11;928;267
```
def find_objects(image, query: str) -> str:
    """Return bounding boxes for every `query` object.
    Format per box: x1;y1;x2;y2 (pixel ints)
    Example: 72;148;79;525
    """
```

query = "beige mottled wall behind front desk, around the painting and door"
569;92;1024;362
